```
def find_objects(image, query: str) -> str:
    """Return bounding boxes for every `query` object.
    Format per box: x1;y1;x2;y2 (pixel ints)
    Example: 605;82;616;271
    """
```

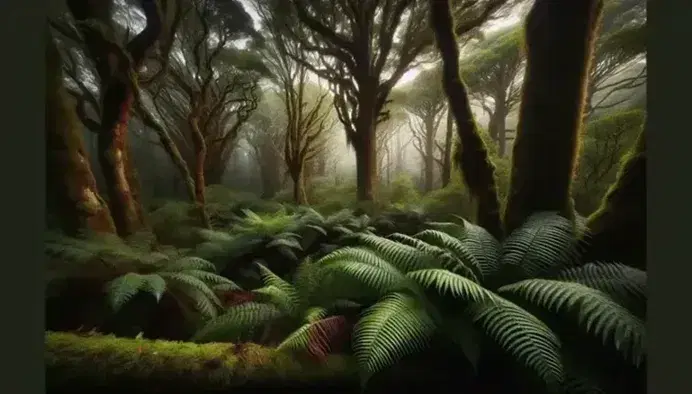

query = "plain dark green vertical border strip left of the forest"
0;0;46;394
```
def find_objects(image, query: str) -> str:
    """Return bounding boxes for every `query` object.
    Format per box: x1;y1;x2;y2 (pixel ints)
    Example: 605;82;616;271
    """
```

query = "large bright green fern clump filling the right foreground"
274;213;645;387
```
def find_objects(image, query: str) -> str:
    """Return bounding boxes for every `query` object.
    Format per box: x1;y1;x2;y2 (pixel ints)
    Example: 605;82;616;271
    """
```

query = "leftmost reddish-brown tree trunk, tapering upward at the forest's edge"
45;36;116;236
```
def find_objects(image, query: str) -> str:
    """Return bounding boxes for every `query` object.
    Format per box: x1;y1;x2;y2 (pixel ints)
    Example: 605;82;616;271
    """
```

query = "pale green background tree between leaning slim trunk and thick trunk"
461;26;524;157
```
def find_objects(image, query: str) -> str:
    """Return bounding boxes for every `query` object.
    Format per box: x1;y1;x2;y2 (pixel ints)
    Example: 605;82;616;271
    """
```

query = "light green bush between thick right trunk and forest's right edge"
572;110;646;215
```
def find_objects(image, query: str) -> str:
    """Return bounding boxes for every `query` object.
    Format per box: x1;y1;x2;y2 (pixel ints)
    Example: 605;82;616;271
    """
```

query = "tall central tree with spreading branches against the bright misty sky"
285;0;507;201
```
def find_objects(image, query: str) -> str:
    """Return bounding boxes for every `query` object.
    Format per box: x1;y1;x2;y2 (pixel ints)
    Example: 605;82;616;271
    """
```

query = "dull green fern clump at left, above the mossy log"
46;235;239;318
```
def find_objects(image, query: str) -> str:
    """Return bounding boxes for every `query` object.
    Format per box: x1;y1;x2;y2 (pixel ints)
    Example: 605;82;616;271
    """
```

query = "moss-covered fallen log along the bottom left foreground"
45;332;358;392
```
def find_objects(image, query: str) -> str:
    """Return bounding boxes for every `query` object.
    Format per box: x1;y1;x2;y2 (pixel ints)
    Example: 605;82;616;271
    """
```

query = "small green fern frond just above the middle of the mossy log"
192;302;283;343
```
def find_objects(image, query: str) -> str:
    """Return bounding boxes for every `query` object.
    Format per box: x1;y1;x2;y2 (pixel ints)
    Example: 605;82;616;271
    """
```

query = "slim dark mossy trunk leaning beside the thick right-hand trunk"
430;0;503;238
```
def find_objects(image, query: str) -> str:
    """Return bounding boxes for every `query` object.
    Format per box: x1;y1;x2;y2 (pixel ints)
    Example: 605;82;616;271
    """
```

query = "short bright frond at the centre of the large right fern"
407;268;494;303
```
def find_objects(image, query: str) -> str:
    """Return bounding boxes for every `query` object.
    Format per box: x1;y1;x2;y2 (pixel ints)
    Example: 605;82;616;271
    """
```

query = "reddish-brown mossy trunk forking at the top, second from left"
67;0;162;236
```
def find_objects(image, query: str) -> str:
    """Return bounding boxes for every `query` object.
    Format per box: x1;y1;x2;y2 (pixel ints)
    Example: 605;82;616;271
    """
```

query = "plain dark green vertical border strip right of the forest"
646;0;692;394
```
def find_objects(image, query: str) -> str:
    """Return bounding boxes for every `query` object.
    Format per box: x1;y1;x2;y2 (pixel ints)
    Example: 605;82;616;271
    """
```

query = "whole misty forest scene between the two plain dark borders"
44;0;647;394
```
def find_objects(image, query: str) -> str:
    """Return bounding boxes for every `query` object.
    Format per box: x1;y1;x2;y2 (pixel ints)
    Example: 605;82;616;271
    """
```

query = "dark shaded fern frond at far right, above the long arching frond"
555;263;647;318
